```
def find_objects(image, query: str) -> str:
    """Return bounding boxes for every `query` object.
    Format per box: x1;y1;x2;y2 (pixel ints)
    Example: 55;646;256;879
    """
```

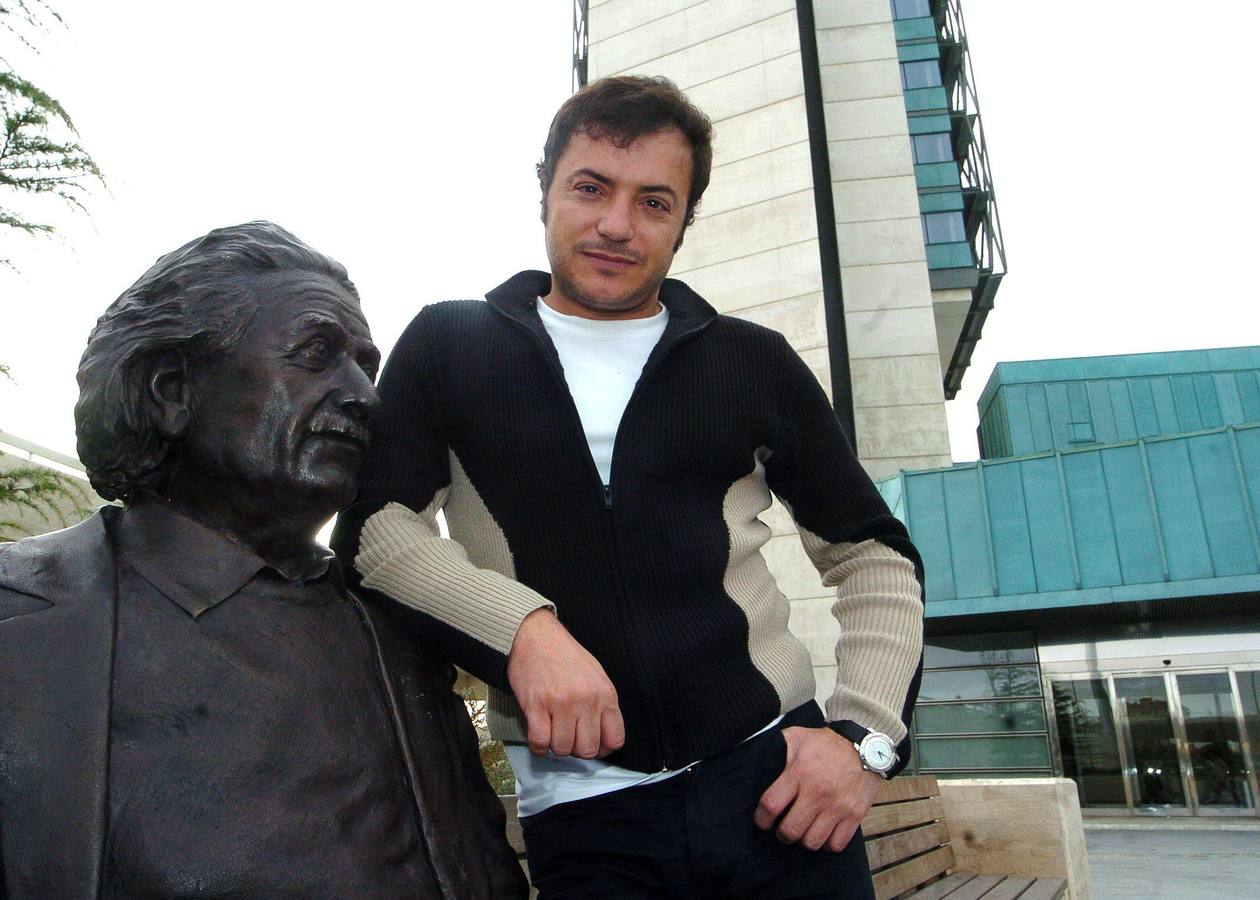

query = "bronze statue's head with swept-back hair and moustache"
74;222;381;533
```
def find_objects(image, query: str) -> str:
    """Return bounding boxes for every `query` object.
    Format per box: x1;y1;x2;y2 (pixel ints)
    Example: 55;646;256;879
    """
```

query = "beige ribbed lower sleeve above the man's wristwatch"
800;528;924;741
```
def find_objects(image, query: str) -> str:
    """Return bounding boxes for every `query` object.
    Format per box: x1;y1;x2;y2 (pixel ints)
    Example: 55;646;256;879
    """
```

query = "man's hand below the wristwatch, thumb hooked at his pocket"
753;726;883;851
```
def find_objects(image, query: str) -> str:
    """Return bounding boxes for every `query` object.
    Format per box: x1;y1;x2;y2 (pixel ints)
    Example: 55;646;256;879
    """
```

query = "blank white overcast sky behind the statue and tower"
0;0;1260;460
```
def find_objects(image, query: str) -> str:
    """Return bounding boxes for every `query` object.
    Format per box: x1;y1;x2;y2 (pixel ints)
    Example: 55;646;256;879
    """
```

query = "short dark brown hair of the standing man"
538;76;713;227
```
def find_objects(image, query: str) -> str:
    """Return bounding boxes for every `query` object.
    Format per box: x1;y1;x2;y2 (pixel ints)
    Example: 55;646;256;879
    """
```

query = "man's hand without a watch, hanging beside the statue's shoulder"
508;609;626;759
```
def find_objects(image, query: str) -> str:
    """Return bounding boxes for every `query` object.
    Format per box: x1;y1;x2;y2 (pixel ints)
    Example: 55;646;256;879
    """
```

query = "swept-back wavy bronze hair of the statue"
74;216;359;500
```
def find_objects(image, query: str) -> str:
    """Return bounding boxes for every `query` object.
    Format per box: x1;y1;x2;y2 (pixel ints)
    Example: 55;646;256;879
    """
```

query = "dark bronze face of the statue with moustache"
176;271;381;527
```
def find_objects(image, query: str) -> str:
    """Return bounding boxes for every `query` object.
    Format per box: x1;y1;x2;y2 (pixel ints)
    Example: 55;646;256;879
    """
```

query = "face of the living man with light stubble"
543;127;692;319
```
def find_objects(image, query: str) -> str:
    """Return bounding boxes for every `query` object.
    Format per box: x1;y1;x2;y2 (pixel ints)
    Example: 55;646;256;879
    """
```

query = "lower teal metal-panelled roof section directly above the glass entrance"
879;425;1260;620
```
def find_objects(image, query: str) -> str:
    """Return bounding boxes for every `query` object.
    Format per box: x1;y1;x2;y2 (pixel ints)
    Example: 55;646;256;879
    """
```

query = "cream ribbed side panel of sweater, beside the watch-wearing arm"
722;447;814;712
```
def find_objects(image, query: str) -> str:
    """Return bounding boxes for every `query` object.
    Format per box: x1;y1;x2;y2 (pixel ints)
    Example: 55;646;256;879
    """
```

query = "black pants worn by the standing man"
522;703;874;900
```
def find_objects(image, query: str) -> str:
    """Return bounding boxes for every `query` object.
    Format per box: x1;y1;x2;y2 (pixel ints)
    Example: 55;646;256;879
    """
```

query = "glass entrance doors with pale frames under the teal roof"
1046;669;1260;816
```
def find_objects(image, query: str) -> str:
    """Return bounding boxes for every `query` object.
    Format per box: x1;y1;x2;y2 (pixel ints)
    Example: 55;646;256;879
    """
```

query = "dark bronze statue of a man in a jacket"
0;222;525;900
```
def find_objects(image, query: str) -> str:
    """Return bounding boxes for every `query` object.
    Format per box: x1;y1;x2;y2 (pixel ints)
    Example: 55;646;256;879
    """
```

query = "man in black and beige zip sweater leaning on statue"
334;77;922;897
